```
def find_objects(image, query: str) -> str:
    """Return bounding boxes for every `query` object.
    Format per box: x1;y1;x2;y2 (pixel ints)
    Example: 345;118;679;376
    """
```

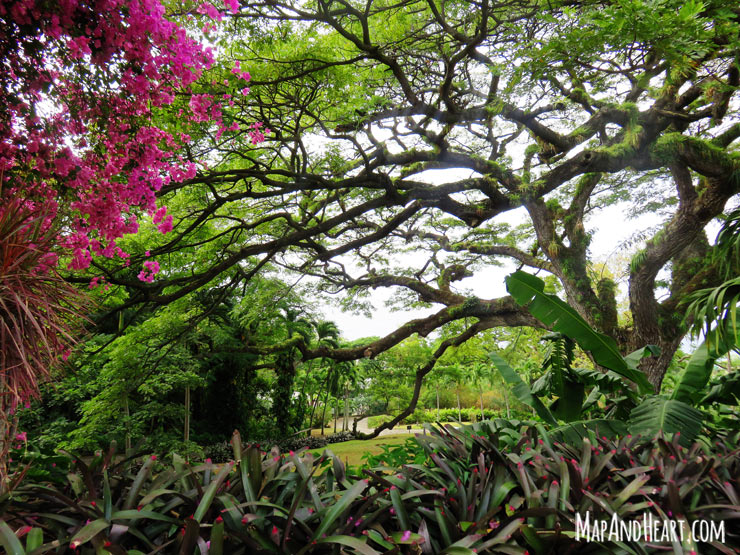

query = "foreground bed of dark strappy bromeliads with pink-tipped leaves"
0;421;740;554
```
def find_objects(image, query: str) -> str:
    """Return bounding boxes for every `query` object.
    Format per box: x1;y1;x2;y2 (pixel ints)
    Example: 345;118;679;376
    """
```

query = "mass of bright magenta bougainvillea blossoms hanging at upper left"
0;0;264;281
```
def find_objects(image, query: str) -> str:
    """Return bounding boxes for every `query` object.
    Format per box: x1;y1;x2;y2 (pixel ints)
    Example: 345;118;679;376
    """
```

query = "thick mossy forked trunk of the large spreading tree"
526;172;735;393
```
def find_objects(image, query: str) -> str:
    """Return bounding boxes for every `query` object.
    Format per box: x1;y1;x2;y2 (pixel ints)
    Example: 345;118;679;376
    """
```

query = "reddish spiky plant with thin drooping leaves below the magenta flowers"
0;199;87;492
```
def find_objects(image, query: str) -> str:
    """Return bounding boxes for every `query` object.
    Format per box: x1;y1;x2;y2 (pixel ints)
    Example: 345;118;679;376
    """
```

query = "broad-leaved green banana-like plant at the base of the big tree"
490;272;740;444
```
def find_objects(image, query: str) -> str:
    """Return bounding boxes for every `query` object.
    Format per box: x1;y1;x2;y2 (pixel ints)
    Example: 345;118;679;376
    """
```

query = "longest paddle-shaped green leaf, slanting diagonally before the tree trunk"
506;272;652;393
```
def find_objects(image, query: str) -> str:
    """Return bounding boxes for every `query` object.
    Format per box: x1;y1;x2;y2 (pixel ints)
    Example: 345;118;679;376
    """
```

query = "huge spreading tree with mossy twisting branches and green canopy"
81;0;740;426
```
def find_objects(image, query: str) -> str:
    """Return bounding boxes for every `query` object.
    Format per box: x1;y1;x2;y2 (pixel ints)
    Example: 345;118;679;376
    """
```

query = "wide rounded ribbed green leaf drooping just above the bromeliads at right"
629;395;703;445
